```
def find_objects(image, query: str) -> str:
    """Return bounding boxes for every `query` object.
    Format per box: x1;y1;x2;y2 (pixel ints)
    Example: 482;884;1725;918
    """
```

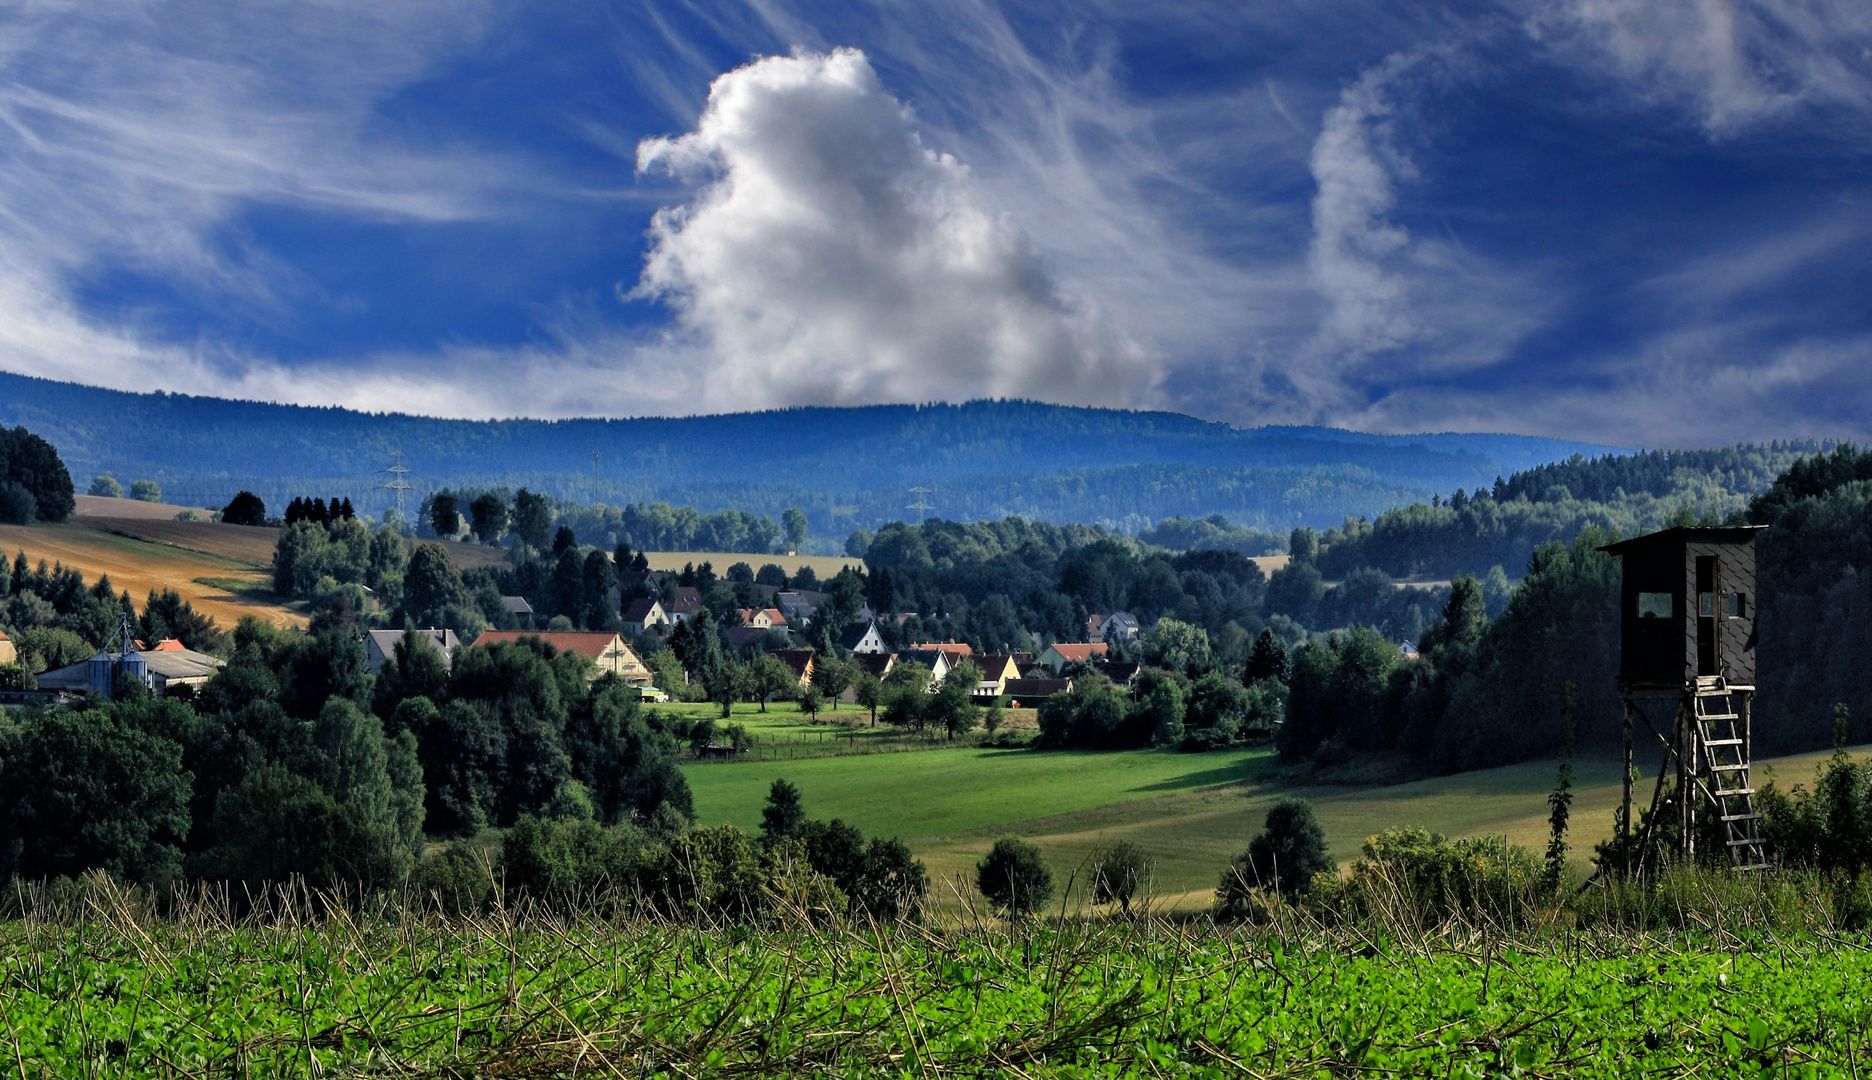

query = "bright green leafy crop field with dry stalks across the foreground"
0;885;1872;1080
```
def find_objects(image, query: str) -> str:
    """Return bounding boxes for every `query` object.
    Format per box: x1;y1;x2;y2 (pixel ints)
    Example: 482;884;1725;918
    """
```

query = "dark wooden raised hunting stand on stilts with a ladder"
1601;526;1767;870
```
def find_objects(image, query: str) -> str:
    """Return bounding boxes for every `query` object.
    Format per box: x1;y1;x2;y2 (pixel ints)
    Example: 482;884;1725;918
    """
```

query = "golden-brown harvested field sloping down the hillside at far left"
0;520;305;629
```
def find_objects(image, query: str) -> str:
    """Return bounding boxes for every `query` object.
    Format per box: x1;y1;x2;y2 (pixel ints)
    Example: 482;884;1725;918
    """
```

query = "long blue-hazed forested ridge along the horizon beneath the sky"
0;372;1606;539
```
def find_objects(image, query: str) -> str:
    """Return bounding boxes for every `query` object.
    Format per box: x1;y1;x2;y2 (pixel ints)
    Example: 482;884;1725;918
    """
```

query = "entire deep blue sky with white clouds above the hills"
0;0;1872;445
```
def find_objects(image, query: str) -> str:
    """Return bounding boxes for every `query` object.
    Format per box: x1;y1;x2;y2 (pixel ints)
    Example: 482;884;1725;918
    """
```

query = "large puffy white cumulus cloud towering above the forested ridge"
635;49;1161;404
